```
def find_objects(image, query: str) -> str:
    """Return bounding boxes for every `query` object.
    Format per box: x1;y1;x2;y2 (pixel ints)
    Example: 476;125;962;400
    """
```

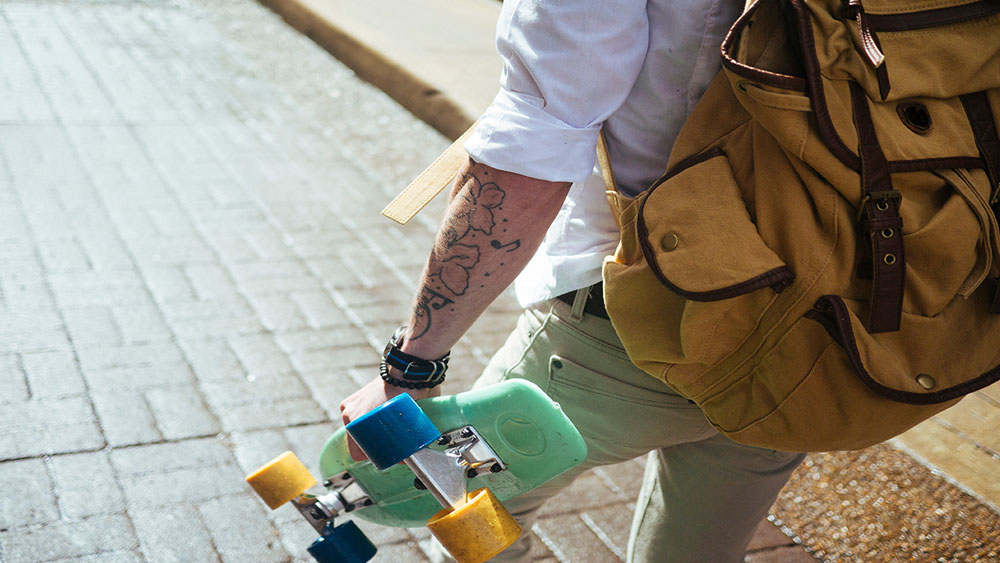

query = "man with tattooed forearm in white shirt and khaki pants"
341;0;802;562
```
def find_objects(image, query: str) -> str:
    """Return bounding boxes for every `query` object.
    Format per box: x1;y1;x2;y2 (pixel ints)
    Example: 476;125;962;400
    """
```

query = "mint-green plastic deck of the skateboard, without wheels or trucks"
319;379;587;527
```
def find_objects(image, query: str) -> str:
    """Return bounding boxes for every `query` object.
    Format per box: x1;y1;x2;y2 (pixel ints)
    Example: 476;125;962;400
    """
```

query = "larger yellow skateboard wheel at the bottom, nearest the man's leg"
427;488;521;563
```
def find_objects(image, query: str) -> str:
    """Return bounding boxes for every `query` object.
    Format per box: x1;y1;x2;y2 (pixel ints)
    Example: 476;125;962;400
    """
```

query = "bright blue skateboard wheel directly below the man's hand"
347;393;441;469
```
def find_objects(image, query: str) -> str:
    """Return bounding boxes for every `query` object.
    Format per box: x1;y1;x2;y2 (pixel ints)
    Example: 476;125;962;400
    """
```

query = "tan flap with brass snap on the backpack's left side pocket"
636;149;795;301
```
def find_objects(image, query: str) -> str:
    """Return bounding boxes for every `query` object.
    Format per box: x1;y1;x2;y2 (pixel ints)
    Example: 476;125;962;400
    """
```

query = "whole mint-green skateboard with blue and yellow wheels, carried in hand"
246;379;587;563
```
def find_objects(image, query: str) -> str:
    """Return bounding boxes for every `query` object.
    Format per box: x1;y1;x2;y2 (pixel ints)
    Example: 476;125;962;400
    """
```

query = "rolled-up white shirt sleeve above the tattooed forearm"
465;0;649;182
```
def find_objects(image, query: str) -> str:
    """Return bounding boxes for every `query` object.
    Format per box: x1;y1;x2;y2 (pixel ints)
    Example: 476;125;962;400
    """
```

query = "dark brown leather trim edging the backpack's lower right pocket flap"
805;295;1000;405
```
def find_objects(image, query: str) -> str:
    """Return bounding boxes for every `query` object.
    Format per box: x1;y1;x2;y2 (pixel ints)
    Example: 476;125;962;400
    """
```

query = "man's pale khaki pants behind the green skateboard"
437;299;804;563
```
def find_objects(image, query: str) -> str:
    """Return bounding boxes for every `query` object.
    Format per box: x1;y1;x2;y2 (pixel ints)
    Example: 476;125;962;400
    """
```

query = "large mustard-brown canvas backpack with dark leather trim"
601;0;1000;451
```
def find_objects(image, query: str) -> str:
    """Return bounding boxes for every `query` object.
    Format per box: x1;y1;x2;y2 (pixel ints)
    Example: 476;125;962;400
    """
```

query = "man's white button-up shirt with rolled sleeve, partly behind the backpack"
465;0;743;306
